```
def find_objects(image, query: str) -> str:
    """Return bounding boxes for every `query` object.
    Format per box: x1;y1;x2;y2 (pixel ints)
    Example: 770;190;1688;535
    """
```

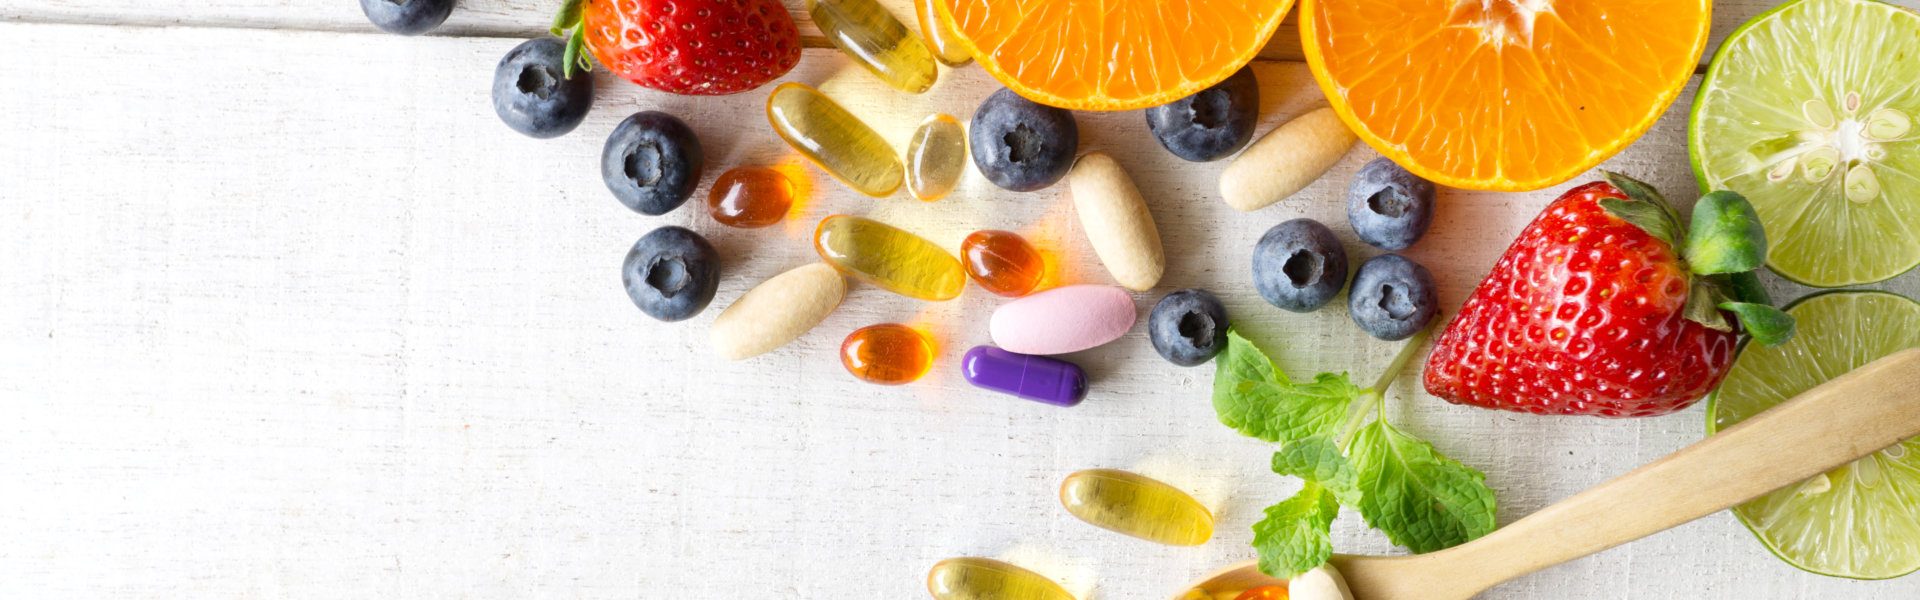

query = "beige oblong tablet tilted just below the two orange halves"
1219;108;1359;212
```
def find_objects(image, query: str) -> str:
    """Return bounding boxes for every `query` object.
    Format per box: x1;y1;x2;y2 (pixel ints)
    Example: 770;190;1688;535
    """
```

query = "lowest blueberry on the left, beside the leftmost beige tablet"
620;225;720;321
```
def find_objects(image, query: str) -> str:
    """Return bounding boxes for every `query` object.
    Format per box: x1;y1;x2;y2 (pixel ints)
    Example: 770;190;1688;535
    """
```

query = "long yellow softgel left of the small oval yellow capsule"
766;83;904;198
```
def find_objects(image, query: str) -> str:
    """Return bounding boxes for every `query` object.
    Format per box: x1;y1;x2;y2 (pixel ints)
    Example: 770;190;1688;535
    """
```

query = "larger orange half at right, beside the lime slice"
1300;0;1711;190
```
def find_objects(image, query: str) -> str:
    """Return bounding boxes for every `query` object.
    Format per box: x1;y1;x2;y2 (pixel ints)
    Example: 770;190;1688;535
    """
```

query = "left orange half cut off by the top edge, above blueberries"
933;0;1292;110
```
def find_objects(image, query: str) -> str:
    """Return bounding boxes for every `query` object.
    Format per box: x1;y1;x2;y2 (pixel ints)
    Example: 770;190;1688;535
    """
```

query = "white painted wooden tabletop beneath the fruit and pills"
0;0;1920;600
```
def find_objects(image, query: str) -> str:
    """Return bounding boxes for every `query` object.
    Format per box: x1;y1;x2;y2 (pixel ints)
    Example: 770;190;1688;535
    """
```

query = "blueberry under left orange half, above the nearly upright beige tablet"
968;88;1079;192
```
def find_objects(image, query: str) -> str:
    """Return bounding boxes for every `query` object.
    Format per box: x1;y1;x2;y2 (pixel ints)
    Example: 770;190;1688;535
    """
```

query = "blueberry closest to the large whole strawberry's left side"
1346;254;1440;342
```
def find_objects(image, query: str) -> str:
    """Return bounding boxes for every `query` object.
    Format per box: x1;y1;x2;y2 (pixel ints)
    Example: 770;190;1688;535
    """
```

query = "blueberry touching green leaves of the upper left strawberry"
493;37;593;138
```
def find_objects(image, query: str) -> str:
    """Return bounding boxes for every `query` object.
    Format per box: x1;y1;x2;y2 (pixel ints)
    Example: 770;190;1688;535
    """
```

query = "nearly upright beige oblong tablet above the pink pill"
1068;152;1167;292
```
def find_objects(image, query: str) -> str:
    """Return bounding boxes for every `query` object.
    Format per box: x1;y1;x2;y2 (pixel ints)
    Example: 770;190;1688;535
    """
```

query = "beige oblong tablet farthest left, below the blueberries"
710;263;847;360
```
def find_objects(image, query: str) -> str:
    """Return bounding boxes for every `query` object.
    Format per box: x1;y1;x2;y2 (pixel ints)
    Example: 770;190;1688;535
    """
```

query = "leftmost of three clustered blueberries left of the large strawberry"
1254;219;1346;312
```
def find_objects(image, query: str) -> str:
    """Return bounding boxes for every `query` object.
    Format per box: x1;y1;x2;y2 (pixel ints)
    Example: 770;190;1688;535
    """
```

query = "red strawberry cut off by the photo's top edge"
553;0;801;96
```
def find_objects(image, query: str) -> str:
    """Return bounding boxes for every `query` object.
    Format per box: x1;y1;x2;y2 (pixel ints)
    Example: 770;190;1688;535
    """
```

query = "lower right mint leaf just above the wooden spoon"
1350;421;1494;554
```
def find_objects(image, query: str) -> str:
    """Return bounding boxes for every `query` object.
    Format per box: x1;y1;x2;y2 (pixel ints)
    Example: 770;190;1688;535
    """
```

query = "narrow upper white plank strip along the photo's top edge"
0;0;1920;63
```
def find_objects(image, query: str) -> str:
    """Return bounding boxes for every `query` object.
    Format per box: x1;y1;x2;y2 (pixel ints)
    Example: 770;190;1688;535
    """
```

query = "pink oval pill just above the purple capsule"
987;285;1135;354
